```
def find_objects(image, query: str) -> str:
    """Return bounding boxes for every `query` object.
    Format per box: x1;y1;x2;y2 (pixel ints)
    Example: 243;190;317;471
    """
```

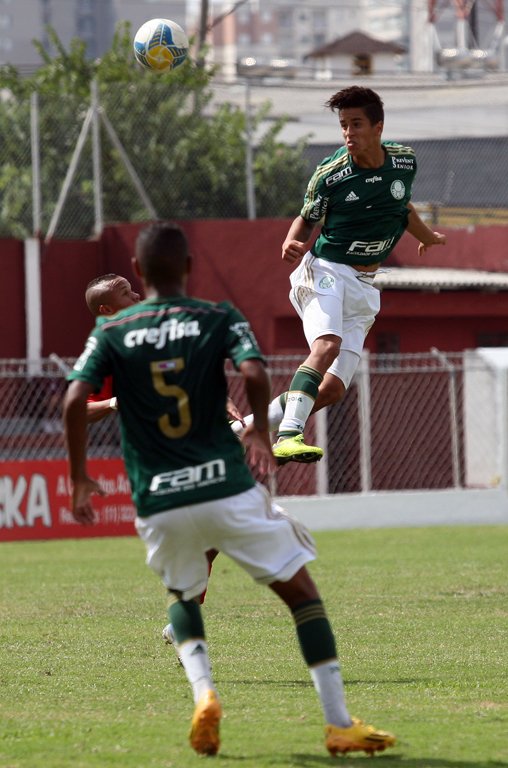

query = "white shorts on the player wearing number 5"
136;483;316;600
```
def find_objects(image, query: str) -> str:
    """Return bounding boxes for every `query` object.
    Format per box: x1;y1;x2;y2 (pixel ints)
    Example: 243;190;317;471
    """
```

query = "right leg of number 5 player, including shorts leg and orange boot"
217;485;394;753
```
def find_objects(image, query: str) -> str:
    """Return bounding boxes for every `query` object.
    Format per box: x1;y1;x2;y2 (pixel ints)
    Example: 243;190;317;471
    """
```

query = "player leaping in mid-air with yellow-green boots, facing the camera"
234;85;446;464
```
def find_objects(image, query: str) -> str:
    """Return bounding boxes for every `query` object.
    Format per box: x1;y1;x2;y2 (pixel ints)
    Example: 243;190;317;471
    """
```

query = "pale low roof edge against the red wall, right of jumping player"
374;267;508;293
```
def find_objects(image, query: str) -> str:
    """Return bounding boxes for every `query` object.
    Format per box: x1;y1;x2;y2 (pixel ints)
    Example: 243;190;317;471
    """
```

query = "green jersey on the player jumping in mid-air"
301;142;416;265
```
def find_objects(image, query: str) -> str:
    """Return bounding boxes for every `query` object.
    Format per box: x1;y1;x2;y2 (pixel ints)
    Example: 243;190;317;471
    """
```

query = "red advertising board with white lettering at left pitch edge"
0;459;136;542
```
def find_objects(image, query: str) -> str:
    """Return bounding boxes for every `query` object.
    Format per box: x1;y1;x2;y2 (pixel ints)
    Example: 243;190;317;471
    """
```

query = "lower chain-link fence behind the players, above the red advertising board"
0;351;500;496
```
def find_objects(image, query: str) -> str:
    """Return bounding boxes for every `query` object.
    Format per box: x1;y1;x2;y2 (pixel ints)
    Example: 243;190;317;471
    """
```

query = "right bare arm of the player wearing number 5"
240;359;276;474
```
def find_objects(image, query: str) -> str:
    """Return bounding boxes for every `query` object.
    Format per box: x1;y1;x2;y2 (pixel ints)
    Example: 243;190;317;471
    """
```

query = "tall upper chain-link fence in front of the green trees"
0;81;508;239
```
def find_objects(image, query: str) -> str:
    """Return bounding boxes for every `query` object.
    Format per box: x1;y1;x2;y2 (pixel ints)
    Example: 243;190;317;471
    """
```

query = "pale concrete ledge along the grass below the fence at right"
276;488;508;531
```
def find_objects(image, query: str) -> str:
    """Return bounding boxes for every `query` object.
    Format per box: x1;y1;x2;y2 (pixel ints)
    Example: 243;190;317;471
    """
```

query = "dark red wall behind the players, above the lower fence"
0;219;508;358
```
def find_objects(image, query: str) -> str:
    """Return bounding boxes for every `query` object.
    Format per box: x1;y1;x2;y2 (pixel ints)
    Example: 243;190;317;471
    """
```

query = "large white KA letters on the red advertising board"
0;473;51;528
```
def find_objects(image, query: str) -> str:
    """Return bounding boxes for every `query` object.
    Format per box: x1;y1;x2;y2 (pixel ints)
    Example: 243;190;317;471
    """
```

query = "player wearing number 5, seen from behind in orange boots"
64;222;395;755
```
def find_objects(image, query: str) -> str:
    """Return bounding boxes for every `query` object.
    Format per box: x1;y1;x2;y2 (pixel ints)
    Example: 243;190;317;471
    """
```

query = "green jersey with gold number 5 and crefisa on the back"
68;297;263;517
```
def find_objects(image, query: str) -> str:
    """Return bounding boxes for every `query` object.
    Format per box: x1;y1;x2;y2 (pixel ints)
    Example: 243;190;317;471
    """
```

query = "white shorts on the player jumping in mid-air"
289;251;380;389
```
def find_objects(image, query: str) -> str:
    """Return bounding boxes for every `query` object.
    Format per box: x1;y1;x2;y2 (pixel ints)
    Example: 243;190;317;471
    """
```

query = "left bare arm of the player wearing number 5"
63;381;104;525
